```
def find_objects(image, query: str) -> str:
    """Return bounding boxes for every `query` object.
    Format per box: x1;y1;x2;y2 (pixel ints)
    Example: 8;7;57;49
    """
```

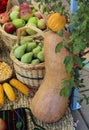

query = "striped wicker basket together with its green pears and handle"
10;26;45;90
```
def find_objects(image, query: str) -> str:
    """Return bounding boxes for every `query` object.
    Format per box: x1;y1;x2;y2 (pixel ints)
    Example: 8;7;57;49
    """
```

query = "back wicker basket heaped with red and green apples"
0;0;47;50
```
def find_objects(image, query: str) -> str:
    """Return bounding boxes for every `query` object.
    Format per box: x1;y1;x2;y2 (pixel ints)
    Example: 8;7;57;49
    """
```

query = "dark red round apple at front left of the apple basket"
4;22;16;34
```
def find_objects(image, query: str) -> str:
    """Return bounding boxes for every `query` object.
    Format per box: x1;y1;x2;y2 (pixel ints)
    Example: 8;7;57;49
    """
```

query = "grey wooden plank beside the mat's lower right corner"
72;110;89;130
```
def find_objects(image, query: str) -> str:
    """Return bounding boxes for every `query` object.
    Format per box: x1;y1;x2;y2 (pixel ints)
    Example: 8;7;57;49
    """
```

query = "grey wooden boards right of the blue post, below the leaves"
72;67;89;130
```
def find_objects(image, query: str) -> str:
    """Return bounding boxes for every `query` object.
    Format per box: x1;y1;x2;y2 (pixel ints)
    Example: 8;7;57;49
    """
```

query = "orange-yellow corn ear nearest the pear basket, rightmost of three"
9;78;29;96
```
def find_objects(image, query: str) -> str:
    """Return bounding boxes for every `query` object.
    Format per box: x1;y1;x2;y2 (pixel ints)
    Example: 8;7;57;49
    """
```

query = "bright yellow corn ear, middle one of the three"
3;83;16;101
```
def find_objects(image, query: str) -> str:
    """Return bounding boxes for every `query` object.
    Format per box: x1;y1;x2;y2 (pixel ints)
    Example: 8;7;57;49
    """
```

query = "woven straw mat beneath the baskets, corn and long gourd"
0;39;73;130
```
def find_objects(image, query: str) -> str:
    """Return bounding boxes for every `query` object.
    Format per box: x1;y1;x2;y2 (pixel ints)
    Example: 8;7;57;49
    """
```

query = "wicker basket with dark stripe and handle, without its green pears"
10;26;45;89
